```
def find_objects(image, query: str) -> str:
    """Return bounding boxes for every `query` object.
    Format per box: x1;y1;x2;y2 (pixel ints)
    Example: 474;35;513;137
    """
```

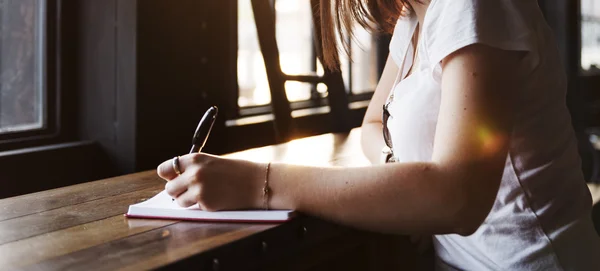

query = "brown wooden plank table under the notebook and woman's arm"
0;130;414;270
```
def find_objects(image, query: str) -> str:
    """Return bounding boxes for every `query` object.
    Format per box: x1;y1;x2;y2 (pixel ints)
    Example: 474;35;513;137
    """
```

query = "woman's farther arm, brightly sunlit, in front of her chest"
361;56;398;164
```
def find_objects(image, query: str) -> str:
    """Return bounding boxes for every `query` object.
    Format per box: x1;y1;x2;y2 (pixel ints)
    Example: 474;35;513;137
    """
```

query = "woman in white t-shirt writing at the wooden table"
158;0;600;270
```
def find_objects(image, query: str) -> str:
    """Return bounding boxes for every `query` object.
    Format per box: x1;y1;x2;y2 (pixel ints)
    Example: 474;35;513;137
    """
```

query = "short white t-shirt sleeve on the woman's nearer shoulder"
422;0;536;67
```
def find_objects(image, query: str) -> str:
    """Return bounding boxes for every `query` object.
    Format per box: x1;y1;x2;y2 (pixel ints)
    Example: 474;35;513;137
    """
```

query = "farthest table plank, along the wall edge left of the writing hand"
0;172;164;221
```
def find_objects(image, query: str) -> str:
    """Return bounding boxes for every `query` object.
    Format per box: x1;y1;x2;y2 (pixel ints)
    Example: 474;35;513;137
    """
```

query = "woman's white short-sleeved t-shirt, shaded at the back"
388;0;600;270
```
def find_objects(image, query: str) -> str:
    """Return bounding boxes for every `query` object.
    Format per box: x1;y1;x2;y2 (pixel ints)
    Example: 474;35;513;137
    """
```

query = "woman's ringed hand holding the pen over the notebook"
157;153;266;211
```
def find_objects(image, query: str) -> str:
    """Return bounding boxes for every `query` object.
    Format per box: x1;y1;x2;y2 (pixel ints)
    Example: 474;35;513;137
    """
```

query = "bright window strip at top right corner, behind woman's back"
581;0;600;71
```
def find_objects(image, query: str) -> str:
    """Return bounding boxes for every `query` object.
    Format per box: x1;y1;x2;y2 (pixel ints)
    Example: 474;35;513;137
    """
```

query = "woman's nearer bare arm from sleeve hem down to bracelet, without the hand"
271;45;520;234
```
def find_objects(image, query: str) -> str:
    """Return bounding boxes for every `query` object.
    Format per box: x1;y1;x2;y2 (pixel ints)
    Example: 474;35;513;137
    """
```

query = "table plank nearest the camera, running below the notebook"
25;222;276;270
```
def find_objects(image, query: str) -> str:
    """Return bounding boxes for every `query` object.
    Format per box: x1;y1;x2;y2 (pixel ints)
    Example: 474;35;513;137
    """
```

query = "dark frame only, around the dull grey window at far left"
0;0;62;151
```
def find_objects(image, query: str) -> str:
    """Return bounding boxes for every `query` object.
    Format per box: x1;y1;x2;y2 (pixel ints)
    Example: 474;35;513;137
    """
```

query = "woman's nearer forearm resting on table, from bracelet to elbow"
270;163;500;238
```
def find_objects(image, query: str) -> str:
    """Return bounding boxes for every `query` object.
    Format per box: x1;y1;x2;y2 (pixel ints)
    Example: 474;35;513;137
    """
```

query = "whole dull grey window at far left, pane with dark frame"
0;0;59;151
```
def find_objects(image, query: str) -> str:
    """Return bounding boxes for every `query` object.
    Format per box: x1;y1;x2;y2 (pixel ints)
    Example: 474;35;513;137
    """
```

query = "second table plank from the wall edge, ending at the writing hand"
0;185;164;244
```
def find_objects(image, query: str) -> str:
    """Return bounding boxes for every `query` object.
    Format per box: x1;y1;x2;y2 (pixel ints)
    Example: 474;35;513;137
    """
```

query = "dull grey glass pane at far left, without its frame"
0;0;45;133
